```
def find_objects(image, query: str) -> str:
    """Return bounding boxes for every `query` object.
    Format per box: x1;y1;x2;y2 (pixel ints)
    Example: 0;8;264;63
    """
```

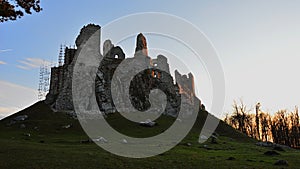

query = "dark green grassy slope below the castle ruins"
0;102;300;169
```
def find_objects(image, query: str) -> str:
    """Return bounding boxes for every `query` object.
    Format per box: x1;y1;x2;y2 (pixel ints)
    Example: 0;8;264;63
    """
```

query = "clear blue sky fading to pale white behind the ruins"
0;0;300;119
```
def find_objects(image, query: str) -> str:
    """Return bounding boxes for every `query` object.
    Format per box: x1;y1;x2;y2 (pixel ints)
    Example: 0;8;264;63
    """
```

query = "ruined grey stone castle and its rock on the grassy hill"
46;24;201;116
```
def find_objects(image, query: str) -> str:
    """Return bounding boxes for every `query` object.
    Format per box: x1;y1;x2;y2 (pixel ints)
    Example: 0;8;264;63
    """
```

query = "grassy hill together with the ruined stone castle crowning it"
0;24;300;169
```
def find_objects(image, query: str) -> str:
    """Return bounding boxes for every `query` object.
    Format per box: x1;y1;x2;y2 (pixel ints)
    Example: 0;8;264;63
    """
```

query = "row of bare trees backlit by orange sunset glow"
224;101;300;148
